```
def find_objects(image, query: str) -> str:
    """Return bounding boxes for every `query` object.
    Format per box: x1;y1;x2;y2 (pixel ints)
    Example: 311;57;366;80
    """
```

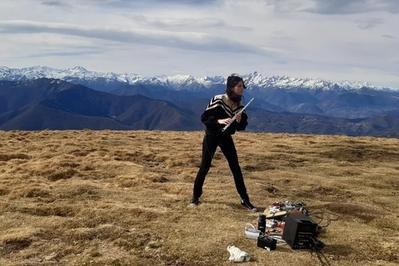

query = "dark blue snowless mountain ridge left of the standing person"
0;78;197;130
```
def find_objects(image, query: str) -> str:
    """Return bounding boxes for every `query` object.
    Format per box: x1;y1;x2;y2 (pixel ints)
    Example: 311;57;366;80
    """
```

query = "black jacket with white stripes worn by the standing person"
201;94;248;135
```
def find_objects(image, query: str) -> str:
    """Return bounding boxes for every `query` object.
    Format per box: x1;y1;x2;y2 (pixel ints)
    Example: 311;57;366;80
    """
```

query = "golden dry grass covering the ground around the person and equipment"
0;130;399;265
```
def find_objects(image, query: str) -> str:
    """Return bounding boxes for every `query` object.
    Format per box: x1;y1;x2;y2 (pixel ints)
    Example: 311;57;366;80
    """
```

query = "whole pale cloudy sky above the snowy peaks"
0;0;399;88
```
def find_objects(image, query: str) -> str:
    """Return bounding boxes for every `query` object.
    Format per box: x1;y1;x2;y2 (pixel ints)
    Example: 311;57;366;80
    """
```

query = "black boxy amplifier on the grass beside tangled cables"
283;215;317;249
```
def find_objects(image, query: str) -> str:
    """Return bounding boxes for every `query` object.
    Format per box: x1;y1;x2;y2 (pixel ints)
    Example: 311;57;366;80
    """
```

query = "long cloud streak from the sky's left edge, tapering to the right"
0;20;272;56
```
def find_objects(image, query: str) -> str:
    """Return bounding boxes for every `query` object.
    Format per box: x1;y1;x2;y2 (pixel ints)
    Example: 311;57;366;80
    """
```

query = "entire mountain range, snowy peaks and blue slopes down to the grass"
0;64;399;136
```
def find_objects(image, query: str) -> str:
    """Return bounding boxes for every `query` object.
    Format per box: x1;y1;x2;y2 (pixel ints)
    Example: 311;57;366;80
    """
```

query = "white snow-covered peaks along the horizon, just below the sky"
0;66;397;90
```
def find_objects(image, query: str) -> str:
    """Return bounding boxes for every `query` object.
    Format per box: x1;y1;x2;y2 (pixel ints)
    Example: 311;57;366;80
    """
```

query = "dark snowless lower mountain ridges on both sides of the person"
0;78;399;137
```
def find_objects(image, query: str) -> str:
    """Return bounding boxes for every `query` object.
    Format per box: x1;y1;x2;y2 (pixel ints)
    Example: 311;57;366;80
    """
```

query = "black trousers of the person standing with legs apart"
193;134;249;200
